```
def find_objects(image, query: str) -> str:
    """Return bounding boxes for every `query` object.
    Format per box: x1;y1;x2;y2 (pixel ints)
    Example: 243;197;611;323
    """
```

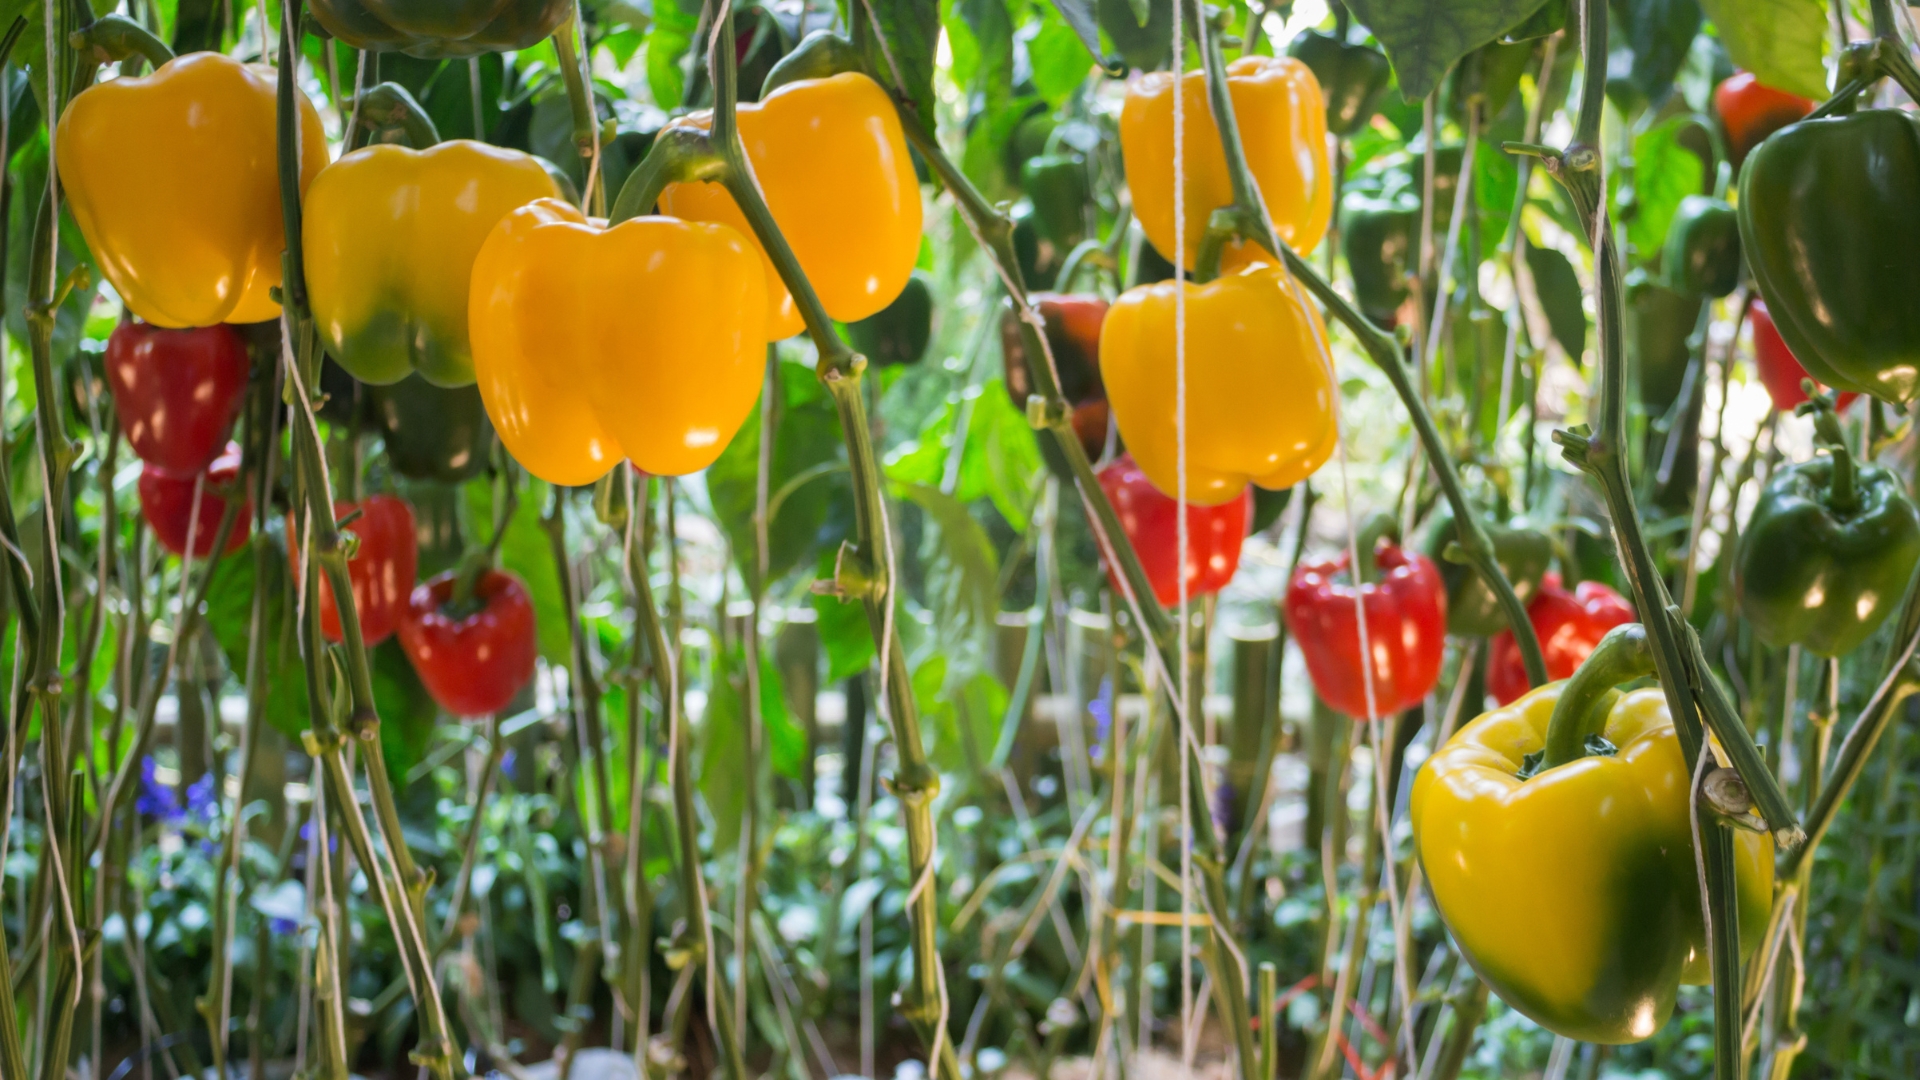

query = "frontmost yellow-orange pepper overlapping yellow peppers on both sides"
468;198;766;484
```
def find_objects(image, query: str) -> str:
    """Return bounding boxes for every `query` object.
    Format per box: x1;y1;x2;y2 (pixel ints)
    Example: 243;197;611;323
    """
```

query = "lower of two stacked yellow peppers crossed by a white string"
1100;265;1334;505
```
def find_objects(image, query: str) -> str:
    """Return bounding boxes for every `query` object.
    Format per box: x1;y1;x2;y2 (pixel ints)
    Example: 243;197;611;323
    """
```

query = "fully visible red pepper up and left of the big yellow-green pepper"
1286;542;1446;717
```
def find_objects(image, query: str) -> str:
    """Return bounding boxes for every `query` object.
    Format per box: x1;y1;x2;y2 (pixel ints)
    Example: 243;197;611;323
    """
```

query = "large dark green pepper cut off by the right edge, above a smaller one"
1740;110;1920;404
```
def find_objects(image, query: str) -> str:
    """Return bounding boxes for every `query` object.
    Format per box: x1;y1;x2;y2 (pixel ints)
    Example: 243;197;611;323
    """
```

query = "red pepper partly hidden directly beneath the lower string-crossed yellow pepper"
1100;454;1254;607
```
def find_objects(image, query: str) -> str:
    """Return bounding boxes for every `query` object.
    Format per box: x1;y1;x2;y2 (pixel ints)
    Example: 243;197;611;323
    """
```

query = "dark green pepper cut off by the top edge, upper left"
311;0;574;60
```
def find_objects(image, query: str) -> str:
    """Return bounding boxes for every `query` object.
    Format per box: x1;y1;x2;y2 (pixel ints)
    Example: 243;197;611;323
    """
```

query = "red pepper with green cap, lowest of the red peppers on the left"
399;571;538;717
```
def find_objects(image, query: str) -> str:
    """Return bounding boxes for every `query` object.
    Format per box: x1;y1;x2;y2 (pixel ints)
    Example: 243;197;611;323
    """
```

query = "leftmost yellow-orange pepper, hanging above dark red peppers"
54;52;326;329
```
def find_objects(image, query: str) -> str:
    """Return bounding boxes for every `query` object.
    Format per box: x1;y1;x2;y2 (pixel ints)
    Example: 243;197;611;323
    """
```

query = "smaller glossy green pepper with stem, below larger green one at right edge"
1734;394;1920;657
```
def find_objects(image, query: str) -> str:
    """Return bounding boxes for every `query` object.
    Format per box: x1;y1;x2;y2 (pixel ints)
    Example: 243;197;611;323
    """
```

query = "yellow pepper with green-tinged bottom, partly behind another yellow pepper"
301;138;561;386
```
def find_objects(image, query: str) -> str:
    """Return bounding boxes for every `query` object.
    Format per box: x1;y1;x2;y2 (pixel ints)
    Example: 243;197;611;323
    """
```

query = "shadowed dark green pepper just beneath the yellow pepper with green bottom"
361;375;493;482
